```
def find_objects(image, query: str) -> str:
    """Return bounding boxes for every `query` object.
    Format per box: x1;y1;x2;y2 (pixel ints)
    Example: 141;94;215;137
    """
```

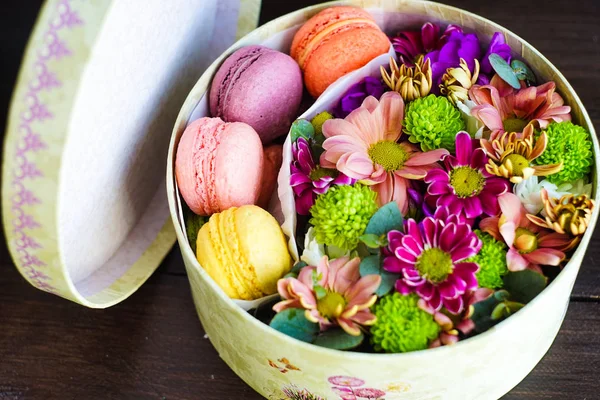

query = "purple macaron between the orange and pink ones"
209;46;303;144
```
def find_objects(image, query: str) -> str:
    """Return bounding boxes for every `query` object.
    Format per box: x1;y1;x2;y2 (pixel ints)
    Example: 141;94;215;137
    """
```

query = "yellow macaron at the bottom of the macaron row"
196;205;292;300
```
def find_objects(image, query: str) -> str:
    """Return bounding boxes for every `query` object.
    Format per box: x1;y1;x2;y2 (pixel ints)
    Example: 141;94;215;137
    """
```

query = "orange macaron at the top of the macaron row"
291;6;391;98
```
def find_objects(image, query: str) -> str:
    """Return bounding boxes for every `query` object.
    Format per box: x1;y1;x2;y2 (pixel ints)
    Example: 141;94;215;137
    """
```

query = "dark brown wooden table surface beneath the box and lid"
0;0;600;400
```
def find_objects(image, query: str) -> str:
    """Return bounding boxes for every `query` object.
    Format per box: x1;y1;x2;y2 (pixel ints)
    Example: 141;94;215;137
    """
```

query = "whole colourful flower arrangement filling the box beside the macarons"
270;23;594;353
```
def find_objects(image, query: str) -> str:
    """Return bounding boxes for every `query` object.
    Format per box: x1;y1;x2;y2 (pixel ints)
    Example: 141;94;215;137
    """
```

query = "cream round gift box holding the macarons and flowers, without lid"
167;0;600;400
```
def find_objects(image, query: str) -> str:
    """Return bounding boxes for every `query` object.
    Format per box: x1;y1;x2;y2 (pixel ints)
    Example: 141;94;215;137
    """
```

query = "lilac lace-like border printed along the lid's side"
10;0;83;294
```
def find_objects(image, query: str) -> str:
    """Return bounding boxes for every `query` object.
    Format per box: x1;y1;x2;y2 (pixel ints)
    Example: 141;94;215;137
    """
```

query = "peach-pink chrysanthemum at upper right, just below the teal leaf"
469;75;571;134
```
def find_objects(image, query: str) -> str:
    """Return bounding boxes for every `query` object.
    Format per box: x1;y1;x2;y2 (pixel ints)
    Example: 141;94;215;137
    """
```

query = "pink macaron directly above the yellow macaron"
175;118;263;216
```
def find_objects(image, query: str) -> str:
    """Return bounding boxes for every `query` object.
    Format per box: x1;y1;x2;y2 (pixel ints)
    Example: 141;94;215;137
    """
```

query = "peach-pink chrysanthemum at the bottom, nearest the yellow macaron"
273;257;381;336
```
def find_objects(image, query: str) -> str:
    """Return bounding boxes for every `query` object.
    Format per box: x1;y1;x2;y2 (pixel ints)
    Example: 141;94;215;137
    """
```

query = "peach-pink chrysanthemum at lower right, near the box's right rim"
479;193;572;272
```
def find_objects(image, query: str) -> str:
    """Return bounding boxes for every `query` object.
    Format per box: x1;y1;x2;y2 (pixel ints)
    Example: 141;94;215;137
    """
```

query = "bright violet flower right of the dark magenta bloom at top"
425;29;481;94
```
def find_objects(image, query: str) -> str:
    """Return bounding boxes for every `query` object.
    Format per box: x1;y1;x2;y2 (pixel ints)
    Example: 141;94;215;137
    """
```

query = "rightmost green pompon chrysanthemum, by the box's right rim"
535;121;594;185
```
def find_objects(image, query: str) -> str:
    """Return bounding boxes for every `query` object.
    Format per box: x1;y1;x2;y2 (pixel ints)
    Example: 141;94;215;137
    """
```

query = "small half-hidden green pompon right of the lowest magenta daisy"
467;229;508;289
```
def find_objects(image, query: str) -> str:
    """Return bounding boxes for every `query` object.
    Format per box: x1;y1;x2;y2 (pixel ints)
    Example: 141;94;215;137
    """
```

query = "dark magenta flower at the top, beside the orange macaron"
392;22;462;67
